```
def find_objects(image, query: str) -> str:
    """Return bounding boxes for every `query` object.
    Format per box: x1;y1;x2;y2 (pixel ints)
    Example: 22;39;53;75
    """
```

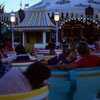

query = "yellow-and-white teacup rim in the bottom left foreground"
0;86;49;100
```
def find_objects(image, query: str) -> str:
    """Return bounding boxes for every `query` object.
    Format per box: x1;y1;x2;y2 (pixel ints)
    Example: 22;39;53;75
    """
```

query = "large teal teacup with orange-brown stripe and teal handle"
48;67;100;100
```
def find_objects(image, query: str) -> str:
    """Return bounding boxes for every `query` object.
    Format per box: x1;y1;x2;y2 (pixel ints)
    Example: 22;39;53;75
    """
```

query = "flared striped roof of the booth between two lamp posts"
14;11;56;30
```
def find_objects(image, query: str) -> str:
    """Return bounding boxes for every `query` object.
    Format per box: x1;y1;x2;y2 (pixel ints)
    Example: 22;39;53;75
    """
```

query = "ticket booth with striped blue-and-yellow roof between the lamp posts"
14;8;56;49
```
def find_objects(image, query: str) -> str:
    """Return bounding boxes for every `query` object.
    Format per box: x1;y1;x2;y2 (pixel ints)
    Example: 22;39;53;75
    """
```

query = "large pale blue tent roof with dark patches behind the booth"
26;0;100;11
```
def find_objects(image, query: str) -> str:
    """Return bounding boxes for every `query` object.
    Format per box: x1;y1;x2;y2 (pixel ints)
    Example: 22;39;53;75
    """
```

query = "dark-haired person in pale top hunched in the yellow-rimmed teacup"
0;62;51;95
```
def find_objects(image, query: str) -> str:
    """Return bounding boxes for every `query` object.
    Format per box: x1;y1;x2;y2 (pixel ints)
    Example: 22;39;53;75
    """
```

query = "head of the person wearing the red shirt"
77;41;89;56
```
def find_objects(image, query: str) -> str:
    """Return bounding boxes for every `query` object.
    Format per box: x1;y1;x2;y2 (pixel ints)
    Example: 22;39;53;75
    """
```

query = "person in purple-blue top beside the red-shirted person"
42;47;76;65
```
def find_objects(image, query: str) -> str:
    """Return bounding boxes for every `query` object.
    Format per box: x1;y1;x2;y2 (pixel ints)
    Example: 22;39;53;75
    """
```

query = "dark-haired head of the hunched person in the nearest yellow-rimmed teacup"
24;62;51;89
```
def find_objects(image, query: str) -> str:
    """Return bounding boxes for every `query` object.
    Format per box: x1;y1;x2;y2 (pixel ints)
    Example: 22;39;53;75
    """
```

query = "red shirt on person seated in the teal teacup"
75;54;100;68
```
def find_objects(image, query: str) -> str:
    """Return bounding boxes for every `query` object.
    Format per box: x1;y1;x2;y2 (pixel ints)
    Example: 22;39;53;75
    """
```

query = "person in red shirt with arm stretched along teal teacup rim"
48;41;100;70
